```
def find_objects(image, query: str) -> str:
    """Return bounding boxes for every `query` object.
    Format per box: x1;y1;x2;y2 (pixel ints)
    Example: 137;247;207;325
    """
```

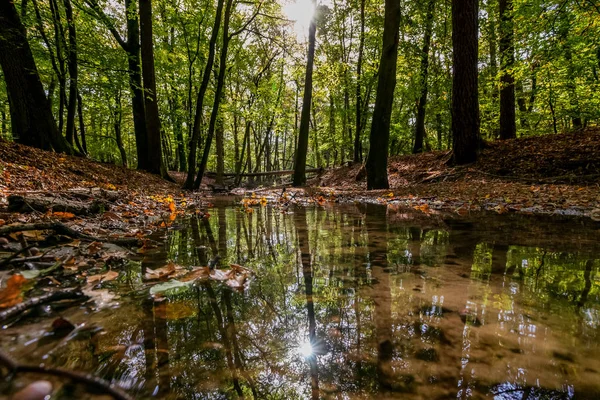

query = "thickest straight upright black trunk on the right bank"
452;0;480;165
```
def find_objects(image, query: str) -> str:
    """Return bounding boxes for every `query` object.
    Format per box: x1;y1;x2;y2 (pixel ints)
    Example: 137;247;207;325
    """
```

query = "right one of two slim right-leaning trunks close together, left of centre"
194;0;233;189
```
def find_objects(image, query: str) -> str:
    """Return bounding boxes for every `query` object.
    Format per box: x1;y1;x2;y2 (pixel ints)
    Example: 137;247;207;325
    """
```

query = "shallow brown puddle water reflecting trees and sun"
0;205;600;399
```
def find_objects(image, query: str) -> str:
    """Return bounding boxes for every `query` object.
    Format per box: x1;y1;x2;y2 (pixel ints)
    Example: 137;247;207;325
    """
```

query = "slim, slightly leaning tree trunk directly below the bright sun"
293;0;317;187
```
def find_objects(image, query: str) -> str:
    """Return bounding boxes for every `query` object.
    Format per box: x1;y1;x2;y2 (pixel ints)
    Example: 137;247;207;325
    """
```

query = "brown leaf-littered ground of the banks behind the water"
0;128;600;225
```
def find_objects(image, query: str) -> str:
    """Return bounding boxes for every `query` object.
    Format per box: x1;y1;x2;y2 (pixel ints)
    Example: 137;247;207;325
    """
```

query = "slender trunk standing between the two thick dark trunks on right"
413;0;435;154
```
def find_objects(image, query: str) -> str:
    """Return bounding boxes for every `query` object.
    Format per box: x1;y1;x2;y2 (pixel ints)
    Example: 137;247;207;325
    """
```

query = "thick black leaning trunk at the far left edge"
0;0;72;153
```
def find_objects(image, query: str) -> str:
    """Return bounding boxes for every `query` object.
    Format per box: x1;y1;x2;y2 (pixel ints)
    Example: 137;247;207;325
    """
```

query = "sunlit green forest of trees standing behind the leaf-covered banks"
0;0;600;189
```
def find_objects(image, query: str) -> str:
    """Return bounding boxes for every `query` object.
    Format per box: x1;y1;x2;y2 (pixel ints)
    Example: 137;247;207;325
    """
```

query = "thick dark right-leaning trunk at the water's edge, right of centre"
366;0;400;190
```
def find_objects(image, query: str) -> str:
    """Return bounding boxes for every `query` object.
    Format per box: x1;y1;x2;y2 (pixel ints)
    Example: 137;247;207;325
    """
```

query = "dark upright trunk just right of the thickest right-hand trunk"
498;0;517;139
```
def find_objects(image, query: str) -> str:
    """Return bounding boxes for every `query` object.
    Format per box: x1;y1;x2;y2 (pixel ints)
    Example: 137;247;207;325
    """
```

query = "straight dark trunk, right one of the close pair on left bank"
140;0;168;178
